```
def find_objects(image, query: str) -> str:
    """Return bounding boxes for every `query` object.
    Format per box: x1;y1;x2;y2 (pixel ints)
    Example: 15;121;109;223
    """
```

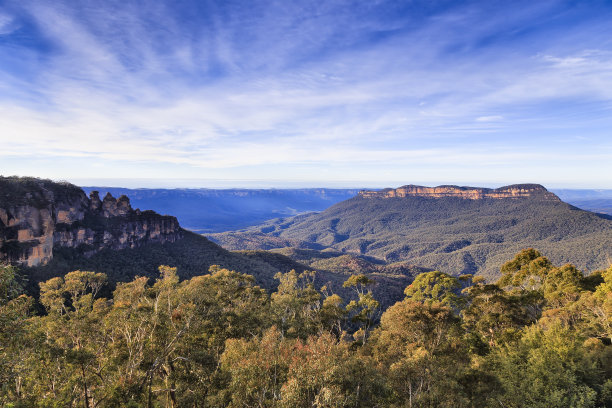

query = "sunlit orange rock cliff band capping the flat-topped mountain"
359;184;561;201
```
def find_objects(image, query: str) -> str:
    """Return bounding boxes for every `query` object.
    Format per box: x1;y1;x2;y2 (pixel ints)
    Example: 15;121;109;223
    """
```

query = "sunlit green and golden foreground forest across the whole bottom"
0;249;612;408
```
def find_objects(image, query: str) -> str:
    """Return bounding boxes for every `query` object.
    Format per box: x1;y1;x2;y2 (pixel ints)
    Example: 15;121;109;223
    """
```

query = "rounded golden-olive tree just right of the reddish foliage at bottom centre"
372;299;495;407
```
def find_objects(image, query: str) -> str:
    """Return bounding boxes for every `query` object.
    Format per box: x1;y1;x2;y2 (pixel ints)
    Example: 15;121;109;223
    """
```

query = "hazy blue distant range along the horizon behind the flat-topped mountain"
83;187;612;233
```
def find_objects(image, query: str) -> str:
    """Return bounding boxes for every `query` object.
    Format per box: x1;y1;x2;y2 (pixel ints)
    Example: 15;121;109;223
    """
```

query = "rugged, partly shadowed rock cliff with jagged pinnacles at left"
0;177;183;266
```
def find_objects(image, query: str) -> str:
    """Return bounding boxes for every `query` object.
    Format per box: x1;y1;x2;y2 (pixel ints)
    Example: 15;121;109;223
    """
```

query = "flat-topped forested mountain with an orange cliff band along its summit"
211;185;612;276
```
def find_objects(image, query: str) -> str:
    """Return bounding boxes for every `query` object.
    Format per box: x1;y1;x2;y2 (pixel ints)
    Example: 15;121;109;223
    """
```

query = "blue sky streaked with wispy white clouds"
0;0;612;188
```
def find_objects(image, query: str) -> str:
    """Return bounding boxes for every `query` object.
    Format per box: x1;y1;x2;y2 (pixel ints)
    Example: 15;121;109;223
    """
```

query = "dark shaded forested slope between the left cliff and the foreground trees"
21;231;416;307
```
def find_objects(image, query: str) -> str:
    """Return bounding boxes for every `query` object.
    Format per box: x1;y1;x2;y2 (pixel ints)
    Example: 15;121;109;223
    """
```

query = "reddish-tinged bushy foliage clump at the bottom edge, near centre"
221;326;381;408
